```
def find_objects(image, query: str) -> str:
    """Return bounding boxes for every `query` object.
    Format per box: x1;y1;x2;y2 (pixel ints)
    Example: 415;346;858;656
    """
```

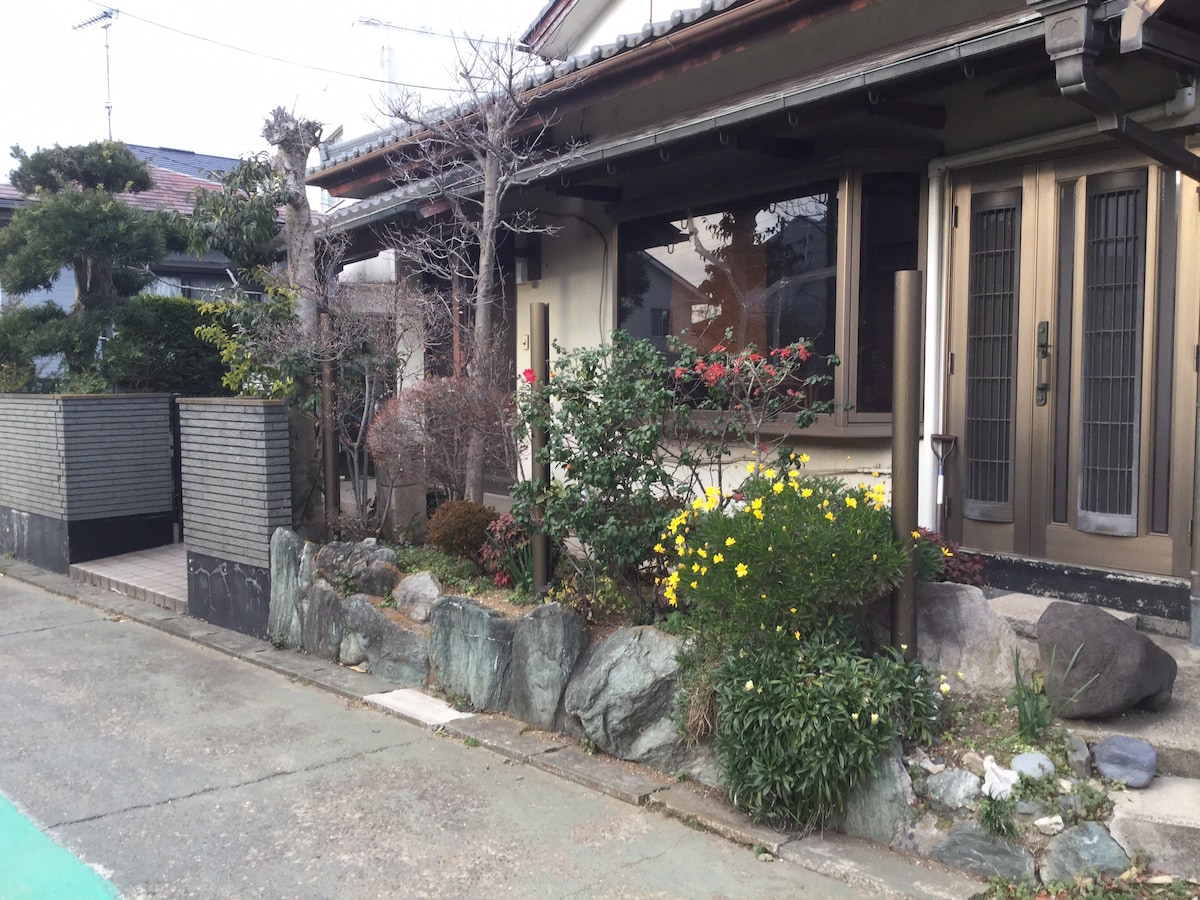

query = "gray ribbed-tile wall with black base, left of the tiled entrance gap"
0;395;174;572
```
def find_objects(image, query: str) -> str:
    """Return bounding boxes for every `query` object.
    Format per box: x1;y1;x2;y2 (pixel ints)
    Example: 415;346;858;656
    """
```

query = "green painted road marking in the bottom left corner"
0;794;121;900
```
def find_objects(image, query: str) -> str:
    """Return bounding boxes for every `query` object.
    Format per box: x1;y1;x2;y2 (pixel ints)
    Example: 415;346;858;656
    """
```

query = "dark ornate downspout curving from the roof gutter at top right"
1028;0;1200;179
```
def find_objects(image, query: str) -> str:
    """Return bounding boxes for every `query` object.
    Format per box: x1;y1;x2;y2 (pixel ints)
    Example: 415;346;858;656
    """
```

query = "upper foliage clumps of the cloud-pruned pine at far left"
0;142;179;311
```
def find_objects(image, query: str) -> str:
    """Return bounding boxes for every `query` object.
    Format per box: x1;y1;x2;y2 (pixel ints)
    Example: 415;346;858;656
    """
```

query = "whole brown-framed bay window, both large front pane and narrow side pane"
618;173;920;422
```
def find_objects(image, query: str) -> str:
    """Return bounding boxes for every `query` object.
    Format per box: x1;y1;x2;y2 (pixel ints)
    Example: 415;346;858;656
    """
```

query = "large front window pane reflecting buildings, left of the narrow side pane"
618;182;838;379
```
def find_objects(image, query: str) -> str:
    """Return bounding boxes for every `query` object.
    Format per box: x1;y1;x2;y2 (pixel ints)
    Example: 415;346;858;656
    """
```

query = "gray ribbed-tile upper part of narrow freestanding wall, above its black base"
179;397;292;569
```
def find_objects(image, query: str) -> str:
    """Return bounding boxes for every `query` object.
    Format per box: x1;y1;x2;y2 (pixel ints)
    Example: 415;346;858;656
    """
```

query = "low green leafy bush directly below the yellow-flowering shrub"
713;629;938;828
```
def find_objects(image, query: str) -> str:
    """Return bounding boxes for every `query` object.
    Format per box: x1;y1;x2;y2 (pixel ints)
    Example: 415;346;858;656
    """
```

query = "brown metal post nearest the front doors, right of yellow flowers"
892;270;922;659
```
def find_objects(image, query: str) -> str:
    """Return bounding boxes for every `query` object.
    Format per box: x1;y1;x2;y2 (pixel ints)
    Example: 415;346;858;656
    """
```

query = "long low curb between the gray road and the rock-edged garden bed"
0;560;983;900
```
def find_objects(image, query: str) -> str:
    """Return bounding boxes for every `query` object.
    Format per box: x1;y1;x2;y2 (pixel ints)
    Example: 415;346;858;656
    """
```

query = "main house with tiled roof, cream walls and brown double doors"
310;0;1200;618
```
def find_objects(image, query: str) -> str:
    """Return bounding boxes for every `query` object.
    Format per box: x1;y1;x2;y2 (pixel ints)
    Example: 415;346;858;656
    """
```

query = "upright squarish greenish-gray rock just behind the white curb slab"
430;596;514;710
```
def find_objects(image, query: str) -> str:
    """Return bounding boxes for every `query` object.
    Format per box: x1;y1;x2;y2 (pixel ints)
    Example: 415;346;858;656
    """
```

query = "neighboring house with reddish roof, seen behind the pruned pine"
0;144;239;310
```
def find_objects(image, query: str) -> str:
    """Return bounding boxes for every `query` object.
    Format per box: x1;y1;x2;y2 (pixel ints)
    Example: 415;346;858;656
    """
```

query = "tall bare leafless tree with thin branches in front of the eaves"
390;42;572;502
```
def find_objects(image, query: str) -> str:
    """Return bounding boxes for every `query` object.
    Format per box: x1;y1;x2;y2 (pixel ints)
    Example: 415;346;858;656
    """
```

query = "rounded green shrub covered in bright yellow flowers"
655;465;907;648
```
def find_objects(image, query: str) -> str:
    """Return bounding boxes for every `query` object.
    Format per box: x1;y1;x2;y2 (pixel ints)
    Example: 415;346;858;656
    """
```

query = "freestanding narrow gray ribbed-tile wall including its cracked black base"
179;398;292;637
